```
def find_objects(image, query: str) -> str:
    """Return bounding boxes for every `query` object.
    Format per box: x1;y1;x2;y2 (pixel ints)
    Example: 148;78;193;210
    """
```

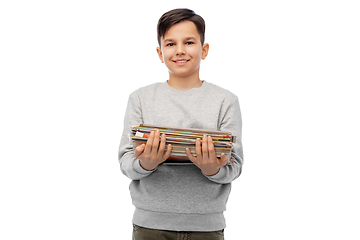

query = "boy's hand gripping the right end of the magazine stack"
186;135;228;176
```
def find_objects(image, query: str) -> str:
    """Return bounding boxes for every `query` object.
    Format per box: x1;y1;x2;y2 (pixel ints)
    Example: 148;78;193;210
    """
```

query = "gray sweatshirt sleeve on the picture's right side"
207;98;244;184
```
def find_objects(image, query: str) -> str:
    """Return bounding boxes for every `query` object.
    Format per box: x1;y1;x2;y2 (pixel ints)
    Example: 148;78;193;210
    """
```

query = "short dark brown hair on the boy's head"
157;8;205;47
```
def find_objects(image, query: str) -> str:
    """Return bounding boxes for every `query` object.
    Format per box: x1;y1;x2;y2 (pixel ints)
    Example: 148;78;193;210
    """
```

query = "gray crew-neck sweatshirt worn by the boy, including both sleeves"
119;81;243;231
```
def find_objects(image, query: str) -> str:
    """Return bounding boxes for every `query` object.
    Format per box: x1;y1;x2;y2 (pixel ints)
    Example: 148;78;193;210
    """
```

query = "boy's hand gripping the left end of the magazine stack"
135;130;171;171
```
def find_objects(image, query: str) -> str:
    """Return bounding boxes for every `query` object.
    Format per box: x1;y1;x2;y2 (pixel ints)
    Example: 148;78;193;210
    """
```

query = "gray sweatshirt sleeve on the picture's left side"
118;92;153;180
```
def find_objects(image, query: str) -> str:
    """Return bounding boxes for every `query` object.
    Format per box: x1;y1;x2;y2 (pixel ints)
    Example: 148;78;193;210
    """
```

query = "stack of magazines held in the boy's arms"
131;124;236;164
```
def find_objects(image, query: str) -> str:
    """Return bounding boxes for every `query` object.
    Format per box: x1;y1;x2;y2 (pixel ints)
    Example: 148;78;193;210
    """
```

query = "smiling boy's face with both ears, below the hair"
157;21;209;78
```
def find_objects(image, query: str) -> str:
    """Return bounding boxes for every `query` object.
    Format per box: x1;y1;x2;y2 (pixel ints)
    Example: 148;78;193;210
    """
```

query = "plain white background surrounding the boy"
0;0;360;240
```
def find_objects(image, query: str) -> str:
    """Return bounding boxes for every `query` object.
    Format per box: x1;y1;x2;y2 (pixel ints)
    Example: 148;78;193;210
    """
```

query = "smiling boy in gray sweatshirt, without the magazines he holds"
119;9;243;240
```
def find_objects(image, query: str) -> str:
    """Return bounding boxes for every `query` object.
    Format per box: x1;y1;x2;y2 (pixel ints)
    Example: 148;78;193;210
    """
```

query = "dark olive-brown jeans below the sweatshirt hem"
132;224;224;240
